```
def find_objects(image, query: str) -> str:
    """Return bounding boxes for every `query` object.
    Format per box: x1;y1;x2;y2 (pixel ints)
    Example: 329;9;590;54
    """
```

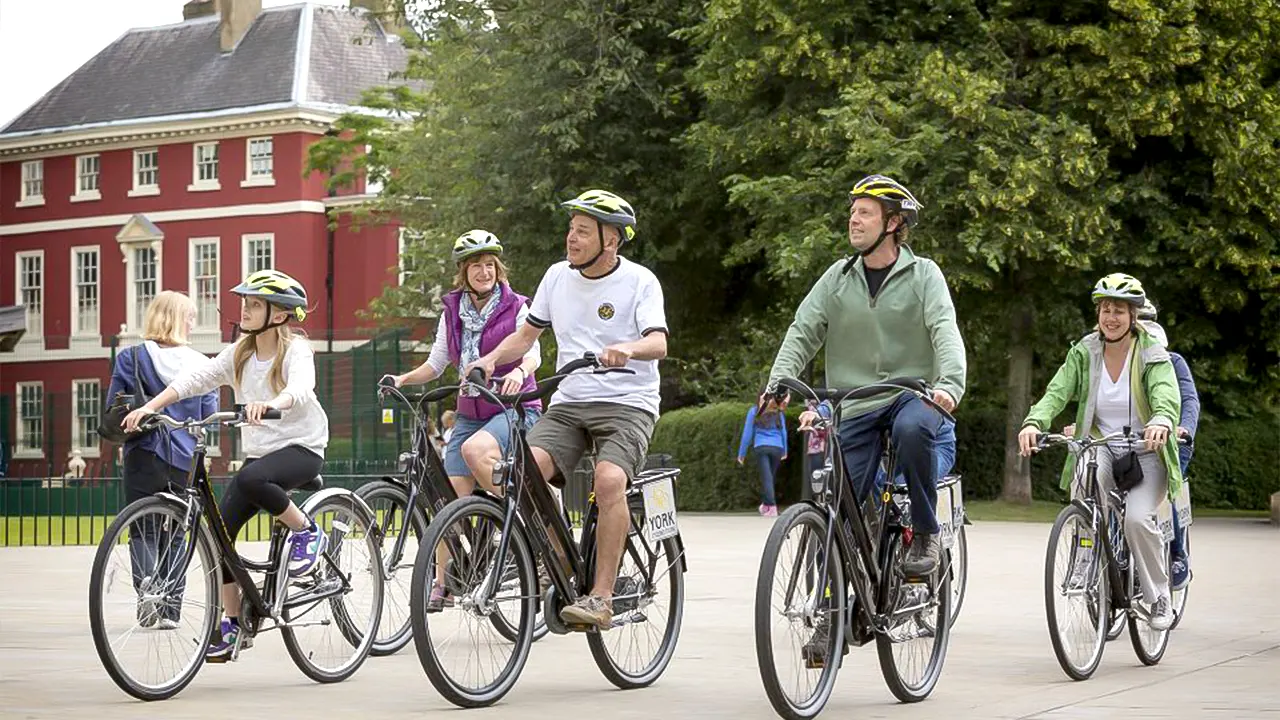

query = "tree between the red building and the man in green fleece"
311;0;733;402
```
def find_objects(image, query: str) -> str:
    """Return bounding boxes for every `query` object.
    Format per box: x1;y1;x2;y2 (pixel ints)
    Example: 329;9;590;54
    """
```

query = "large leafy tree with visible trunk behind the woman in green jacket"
685;0;1280;502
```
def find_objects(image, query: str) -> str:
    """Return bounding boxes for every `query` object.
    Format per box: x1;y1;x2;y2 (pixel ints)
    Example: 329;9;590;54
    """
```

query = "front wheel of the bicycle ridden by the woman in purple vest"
356;480;426;657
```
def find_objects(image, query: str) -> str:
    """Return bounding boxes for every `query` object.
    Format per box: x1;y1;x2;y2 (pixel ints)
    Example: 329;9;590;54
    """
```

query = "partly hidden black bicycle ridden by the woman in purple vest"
356;379;547;657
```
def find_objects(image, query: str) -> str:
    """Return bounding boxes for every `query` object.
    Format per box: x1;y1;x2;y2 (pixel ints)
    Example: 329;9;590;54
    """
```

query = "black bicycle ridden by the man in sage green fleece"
755;378;959;720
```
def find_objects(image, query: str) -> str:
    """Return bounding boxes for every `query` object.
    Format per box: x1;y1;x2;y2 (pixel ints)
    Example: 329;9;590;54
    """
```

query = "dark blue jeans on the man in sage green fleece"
840;392;943;536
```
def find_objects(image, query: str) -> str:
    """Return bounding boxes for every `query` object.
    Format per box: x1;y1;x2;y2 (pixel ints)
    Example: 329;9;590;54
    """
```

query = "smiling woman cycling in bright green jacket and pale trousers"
1018;273;1183;630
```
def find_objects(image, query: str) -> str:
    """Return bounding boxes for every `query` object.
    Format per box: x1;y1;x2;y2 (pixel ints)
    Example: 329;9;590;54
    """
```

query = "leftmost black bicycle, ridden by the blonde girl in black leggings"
90;410;383;701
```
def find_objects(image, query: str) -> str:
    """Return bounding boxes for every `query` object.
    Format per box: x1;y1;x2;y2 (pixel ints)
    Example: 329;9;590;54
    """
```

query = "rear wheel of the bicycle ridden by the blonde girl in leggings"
280;492;384;683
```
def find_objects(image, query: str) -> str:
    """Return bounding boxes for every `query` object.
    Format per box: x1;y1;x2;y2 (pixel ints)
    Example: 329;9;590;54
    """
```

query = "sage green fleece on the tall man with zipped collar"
769;245;965;418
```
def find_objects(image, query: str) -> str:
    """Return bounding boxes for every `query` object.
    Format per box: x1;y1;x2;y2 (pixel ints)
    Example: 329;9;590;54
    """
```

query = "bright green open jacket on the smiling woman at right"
1023;323;1183;497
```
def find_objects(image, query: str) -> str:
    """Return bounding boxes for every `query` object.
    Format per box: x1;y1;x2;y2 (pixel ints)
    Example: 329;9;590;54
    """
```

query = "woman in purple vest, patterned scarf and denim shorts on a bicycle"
378;229;543;611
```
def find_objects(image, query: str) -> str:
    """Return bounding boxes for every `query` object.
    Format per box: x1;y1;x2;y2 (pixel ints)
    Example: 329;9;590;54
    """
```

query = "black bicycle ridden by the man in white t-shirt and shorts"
411;354;687;707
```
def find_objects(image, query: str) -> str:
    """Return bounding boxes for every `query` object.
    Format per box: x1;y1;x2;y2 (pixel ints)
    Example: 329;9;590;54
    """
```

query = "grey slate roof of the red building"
0;4;407;136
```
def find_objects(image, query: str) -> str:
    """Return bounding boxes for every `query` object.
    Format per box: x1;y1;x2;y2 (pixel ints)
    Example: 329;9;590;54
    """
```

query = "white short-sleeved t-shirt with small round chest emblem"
529;258;667;418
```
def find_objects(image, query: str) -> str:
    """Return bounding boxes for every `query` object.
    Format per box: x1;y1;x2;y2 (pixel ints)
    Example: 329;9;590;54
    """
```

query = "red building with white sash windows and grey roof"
0;0;406;478
